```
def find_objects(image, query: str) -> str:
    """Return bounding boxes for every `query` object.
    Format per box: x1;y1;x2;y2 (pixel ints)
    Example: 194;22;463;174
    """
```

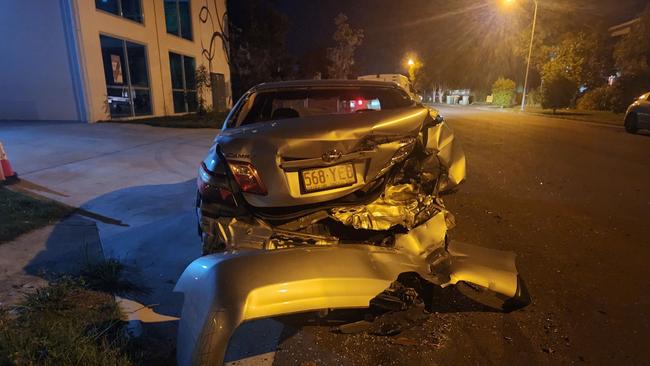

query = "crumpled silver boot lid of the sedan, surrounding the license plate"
216;106;429;207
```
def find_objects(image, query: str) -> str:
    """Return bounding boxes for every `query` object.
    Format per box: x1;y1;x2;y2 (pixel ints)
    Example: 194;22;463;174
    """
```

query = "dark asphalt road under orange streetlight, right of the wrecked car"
274;107;650;365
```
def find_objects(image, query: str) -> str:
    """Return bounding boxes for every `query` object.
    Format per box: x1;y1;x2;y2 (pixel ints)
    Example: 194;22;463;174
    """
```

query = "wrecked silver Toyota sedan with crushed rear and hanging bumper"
176;80;525;365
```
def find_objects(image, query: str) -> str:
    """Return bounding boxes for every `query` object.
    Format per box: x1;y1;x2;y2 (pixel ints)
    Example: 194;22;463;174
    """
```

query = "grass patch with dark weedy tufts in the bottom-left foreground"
0;260;159;366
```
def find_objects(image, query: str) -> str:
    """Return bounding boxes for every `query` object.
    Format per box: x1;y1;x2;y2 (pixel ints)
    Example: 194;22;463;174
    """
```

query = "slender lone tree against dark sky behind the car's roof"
327;13;363;79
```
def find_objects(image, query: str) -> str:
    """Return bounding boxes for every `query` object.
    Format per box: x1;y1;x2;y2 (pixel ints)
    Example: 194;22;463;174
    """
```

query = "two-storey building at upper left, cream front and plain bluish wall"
0;0;231;122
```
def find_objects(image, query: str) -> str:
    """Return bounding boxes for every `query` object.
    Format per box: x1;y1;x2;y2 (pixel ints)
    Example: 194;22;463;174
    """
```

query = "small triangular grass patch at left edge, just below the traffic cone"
0;186;73;243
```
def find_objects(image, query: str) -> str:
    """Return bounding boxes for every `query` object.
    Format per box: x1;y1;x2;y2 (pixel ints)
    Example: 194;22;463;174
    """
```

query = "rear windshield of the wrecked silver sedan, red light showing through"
233;87;413;126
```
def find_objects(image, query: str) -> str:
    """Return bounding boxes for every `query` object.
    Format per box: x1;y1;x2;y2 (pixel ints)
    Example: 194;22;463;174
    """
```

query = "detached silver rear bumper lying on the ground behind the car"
175;243;518;365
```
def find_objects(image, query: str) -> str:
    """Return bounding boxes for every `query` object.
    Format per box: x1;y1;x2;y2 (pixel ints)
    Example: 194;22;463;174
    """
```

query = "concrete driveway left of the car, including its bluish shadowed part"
0;122;210;344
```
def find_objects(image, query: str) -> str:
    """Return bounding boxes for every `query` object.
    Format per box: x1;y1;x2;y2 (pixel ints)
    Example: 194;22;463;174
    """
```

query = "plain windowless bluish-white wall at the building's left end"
0;0;83;120
